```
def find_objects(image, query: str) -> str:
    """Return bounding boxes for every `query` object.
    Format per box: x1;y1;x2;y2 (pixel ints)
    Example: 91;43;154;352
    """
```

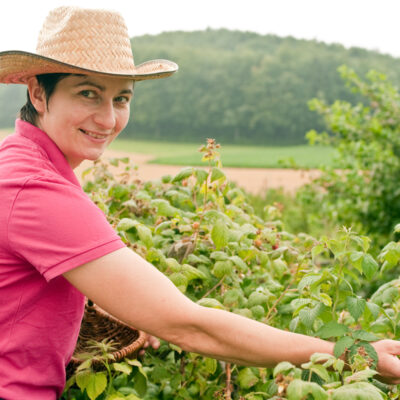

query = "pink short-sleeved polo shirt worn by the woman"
0;120;124;400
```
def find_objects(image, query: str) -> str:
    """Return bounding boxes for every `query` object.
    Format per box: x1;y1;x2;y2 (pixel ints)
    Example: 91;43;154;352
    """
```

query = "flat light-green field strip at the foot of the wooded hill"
110;139;334;168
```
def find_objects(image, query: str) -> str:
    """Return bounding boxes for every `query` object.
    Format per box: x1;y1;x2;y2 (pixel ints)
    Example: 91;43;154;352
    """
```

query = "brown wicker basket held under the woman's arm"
67;300;146;378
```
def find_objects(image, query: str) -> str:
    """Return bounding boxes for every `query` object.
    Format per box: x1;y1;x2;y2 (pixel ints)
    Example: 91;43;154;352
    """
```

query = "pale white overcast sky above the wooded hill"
0;0;400;57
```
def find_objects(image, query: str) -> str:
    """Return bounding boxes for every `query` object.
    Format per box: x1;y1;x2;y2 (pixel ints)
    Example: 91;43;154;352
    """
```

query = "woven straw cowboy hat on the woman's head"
0;7;178;83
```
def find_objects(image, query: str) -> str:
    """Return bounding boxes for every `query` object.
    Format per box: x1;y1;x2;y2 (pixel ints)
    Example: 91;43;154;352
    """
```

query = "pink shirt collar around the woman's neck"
15;119;80;187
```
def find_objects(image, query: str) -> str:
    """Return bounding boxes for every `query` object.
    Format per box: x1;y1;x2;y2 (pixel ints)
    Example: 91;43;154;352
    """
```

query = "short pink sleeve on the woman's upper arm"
8;179;125;281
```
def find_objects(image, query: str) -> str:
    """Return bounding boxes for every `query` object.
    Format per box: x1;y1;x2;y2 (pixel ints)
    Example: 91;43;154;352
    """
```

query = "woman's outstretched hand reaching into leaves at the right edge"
372;339;400;385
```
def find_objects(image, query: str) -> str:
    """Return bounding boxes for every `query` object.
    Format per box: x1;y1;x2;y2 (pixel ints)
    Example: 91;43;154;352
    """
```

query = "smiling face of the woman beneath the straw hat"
28;75;133;168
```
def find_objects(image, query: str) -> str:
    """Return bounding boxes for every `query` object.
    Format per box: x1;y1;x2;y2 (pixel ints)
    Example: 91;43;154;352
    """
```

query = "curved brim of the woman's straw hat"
0;50;178;84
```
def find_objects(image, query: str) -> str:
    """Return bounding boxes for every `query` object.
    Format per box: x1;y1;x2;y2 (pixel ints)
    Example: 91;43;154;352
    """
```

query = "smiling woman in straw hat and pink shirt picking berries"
0;7;400;400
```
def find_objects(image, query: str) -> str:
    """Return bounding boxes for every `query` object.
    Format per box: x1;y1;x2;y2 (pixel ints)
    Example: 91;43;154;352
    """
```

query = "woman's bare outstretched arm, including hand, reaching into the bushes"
64;248;400;379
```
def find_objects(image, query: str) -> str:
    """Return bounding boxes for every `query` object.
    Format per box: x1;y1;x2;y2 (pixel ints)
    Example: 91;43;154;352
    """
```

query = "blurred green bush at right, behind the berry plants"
299;66;400;244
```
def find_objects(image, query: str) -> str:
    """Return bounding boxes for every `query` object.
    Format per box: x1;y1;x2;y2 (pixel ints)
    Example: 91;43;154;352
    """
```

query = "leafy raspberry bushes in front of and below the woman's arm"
64;140;400;400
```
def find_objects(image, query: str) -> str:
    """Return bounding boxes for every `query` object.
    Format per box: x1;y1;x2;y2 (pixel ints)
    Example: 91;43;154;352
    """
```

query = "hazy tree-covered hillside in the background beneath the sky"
0;29;400;145
